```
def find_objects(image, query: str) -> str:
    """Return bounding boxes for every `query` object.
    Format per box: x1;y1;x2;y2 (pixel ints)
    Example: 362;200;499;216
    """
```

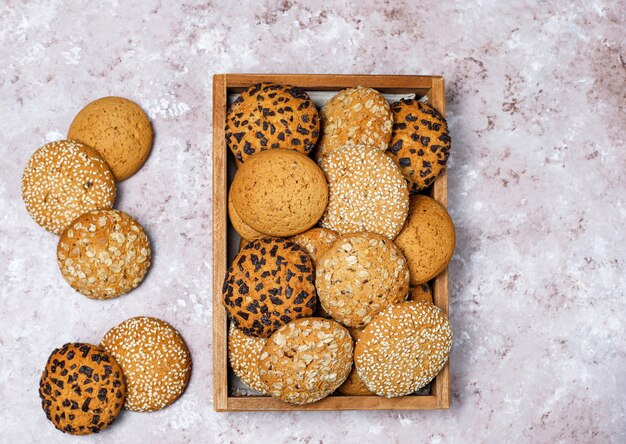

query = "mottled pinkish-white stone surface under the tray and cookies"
0;0;626;443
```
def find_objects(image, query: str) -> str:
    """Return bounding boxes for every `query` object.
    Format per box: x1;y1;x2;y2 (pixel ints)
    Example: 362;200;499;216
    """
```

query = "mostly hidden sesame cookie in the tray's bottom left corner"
228;323;267;395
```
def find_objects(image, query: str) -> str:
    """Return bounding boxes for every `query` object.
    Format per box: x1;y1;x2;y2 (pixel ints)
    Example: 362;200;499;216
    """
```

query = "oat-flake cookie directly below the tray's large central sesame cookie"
315;233;409;327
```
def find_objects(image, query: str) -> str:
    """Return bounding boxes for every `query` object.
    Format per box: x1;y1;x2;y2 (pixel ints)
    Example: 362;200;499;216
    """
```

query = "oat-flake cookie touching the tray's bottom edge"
259;318;353;404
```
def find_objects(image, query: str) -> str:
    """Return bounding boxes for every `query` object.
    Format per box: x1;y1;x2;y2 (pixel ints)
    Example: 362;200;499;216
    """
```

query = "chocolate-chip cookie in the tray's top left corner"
226;83;320;162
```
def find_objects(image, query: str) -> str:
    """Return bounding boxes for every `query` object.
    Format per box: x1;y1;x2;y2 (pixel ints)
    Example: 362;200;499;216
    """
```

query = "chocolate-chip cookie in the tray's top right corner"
389;99;450;194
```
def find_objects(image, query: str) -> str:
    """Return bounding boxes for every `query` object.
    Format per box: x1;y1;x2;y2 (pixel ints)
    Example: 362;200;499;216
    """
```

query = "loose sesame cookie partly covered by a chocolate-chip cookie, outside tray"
100;316;191;412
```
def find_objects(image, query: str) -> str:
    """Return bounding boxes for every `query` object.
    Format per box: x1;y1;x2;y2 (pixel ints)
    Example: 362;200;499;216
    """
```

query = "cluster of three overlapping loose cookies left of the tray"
22;97;152;299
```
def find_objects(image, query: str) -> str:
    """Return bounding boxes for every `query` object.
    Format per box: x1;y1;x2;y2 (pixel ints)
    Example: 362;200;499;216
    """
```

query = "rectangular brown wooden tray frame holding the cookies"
213;74;450;412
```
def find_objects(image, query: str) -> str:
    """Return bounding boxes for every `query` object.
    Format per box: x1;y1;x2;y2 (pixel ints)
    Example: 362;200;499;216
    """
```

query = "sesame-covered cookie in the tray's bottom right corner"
354;302;452;398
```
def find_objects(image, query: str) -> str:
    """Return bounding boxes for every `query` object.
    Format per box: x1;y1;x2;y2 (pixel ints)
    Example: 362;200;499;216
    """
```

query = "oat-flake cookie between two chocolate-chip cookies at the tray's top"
316;86;393;162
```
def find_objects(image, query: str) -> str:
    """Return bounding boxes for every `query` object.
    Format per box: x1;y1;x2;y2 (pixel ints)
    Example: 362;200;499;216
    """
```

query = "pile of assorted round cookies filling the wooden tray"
222;83;455;404
